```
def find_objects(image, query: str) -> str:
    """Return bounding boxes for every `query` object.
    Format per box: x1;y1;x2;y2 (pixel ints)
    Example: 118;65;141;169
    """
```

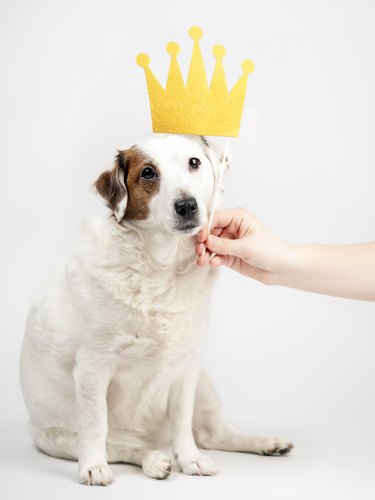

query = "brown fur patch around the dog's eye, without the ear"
125;146;160;220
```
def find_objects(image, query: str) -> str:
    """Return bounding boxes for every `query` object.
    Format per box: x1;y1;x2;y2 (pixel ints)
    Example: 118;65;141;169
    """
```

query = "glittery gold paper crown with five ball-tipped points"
137;26;254;137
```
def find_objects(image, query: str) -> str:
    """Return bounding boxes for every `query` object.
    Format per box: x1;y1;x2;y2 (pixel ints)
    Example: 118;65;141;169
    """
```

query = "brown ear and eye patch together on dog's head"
95;146;160;222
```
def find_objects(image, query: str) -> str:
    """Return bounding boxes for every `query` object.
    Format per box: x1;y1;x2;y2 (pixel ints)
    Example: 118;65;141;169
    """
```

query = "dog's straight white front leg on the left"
74;353;112;485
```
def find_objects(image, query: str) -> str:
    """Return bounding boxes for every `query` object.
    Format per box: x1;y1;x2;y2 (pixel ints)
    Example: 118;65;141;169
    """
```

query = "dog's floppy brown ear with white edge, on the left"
95;151;128;222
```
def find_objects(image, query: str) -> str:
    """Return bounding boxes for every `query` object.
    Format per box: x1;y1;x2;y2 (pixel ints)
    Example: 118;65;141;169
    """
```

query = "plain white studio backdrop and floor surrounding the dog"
0;0;375;500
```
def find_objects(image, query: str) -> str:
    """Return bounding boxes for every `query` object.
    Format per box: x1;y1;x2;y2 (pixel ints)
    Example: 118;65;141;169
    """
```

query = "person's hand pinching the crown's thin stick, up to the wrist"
196;208;293;284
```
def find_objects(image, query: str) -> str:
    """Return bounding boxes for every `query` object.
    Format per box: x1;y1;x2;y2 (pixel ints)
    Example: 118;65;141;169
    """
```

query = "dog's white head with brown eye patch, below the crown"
95;135;229;235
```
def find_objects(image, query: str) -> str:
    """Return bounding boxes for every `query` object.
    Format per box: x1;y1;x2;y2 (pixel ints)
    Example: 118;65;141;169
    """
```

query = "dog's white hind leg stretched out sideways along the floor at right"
193;371;293;456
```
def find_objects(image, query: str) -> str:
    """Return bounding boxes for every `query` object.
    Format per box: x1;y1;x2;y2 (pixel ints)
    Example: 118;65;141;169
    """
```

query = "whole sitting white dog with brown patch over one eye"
21;135;292;485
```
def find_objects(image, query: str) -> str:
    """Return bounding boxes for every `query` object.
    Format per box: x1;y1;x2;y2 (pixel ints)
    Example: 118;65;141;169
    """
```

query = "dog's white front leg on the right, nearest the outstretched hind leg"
169;359;217;476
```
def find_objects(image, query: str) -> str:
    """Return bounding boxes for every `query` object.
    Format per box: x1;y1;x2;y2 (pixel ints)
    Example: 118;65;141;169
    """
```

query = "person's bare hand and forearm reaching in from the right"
196;208;375;301
